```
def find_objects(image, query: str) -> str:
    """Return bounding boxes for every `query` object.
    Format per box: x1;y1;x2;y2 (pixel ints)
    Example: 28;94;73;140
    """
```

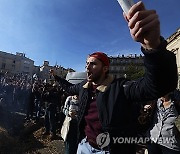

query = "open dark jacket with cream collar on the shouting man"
55;46;177;152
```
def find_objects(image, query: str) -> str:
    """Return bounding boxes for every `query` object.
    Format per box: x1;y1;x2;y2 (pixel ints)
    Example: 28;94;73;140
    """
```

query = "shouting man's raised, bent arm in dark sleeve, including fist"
124;2;177;101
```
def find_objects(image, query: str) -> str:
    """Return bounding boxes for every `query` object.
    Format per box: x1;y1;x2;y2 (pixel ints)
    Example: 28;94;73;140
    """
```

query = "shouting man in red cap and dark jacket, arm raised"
50;2;177;154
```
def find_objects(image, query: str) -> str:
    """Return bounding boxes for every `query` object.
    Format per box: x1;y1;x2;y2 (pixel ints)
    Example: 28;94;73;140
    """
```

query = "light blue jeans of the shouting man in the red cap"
77;138;110;154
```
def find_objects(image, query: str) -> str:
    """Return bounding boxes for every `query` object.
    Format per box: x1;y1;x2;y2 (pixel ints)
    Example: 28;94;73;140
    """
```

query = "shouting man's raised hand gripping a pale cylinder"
124;1;160;49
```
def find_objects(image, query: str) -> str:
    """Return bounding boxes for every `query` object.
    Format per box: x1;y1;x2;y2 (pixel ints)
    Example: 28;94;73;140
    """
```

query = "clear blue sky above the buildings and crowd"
0;0;180;71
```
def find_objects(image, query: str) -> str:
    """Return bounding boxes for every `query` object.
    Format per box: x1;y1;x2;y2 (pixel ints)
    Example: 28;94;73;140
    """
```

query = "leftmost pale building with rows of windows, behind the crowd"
0;51;34;75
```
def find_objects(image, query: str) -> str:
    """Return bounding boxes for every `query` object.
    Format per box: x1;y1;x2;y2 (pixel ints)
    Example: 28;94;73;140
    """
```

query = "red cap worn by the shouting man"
89;51;109;67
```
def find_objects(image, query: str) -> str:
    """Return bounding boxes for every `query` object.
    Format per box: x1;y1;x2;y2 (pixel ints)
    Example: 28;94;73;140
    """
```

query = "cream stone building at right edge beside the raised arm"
167;28;180;89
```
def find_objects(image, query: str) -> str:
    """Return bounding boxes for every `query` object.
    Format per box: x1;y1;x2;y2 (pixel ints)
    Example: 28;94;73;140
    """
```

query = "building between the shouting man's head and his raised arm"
109;54;144;78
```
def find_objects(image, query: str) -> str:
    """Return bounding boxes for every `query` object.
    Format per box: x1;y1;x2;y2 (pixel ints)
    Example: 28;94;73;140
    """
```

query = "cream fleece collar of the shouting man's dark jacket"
83;75;114;92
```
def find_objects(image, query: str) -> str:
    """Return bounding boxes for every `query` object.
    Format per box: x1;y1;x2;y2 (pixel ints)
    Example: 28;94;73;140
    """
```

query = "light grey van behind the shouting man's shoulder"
66;72;87;84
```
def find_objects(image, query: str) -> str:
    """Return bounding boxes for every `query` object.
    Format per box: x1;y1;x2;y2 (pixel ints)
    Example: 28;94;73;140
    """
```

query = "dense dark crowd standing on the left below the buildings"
0;73;68;139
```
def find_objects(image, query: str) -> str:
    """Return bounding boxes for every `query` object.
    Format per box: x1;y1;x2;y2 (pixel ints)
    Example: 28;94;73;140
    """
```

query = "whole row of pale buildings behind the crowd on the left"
0;51;74;79
